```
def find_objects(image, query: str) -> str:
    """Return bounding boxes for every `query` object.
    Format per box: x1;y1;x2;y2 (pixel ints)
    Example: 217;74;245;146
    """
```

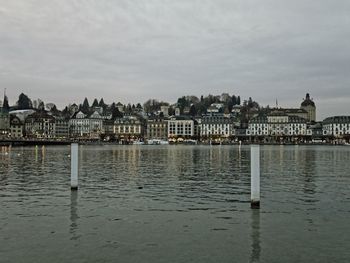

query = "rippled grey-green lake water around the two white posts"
0;145;350;262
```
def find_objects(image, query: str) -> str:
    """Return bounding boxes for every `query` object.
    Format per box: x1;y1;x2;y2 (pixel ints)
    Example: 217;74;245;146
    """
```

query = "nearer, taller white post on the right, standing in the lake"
250;145;260;208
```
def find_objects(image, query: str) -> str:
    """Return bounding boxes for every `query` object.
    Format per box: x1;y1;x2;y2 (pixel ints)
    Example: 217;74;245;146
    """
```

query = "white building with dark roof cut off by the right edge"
322;116;350;137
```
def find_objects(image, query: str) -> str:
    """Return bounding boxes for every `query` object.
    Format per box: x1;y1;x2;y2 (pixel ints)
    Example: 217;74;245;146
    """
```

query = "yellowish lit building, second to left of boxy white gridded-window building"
114;116;145;142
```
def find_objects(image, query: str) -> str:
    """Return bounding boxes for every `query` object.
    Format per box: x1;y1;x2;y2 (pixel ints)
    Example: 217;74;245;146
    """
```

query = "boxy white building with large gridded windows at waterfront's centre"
168;116;195;139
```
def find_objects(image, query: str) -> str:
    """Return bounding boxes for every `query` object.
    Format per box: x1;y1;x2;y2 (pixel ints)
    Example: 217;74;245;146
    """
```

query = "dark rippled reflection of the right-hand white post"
249;209;261;262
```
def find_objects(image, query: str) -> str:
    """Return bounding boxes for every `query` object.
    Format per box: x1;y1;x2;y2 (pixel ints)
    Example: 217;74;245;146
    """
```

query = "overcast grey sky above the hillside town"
0;0;350;120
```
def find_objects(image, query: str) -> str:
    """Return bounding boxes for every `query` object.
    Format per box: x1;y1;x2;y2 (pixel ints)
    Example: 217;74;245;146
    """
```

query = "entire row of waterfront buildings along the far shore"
0;94;350;143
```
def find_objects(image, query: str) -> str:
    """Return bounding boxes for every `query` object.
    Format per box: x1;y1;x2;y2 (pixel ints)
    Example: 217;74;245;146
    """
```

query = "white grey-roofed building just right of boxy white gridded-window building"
199;114;235;140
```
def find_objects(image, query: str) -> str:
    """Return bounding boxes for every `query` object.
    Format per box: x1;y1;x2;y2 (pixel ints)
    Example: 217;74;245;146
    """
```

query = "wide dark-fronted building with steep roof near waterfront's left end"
24;110;56;139
